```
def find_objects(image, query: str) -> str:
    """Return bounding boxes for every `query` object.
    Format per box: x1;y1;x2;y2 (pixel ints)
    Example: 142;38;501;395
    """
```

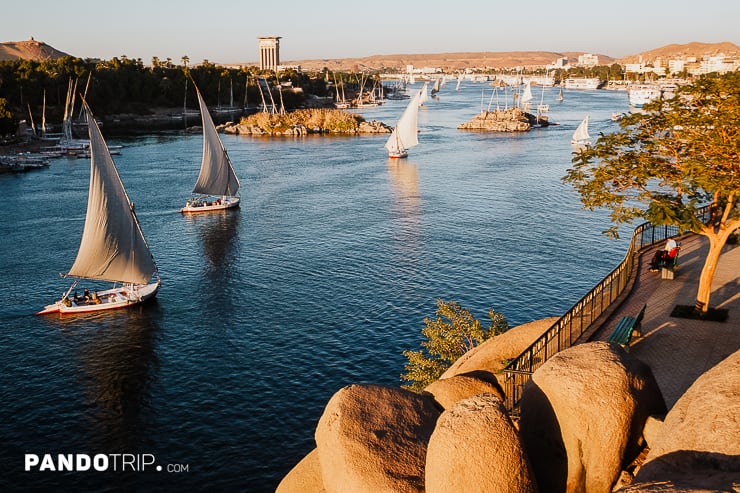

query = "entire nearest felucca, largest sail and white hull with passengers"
37;99;160;315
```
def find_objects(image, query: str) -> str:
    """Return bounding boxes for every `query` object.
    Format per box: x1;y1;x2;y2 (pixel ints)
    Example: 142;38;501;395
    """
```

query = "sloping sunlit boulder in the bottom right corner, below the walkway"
634;351;740;491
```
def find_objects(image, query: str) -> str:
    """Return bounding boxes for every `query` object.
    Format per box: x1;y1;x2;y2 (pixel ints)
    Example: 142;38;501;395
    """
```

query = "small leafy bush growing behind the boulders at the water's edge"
401;300;509;392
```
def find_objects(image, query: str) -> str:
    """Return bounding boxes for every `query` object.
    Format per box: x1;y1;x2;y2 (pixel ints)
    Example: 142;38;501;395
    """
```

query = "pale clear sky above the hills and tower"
0;0;740;63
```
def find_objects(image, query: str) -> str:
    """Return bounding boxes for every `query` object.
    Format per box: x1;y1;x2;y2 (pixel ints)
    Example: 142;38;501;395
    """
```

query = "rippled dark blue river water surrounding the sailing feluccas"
0;82;629;492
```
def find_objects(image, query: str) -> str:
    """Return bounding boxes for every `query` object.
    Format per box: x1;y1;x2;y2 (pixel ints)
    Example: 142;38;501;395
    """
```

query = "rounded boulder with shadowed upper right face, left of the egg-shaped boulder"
315;385;440;493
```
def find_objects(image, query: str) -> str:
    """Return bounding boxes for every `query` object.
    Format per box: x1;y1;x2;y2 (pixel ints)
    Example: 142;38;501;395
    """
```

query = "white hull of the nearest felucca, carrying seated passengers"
36;280;160;315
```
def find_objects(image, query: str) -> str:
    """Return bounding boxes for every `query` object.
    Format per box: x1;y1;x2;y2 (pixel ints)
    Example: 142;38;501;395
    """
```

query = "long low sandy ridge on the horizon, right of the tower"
282;51;614;71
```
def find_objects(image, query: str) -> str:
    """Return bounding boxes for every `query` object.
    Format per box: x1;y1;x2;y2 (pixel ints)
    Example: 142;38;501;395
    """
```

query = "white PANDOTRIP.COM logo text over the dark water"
24;454;190;473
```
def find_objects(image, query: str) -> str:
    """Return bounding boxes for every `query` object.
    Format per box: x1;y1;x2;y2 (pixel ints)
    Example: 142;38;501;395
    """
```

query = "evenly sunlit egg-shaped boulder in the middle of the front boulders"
426;394;537;493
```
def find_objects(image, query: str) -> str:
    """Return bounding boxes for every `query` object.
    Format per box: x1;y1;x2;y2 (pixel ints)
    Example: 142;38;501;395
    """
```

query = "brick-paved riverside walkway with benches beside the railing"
590;235;740;409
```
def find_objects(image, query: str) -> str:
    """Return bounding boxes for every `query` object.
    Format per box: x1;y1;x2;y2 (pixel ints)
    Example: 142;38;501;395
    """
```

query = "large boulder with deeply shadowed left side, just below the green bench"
519;342;666;493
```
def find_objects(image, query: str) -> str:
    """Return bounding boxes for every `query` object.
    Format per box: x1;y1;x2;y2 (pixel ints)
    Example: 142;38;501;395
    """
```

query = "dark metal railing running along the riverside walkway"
499;211;709;412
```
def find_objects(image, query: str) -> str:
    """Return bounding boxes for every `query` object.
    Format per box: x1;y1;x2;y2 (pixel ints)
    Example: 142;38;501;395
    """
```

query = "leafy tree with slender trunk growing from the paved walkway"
563;72;740;313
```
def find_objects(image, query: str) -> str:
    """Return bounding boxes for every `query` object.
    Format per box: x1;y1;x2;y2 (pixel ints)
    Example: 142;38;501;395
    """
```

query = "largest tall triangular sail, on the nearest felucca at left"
69;101;157;284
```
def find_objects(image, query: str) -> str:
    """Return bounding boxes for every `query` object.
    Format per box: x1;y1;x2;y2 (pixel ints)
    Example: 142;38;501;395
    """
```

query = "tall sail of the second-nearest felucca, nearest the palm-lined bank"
193;87;239;196
